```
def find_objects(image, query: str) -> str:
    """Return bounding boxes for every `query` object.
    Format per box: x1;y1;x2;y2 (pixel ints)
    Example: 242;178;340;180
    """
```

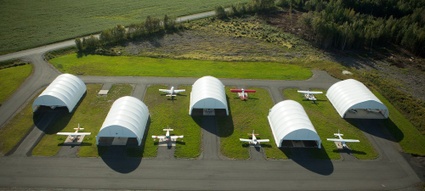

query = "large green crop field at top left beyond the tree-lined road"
0;0;249;54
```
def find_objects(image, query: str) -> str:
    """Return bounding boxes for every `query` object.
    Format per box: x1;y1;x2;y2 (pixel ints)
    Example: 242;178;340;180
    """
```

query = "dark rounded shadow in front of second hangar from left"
97;146;142;174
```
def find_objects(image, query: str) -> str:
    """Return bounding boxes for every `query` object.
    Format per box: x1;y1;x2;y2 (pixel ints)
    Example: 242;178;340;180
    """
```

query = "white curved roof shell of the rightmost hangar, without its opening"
326;79;388;118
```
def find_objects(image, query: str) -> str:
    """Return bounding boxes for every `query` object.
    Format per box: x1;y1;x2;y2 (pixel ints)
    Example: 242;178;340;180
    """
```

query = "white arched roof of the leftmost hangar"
32;74;87;113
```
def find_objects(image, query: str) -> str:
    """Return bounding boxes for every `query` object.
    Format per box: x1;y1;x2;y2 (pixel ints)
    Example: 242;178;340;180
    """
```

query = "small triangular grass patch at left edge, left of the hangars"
0;64;32;104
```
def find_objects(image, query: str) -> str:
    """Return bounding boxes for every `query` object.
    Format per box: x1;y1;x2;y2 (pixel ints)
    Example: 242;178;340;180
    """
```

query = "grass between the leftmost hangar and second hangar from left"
32;84;133;157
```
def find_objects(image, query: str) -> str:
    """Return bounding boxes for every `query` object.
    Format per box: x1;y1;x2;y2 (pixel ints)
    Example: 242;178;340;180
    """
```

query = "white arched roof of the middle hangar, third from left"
189;76;229;115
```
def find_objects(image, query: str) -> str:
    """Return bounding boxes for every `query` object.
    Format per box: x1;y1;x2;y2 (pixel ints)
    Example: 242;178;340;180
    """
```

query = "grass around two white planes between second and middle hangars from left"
143;85;201;158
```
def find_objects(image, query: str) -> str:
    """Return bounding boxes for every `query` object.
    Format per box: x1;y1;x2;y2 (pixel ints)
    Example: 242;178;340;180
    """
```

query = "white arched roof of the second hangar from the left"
96;96;149;146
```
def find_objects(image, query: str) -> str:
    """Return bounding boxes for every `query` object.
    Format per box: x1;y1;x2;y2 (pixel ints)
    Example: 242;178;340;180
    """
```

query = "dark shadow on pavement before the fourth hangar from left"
280;145;334;175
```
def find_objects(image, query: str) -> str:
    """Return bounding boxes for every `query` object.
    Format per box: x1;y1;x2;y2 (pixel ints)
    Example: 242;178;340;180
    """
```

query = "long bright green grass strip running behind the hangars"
50;54;312;80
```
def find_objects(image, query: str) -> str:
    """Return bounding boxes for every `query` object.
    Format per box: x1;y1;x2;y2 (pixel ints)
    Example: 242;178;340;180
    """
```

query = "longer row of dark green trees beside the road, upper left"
75;15;180;54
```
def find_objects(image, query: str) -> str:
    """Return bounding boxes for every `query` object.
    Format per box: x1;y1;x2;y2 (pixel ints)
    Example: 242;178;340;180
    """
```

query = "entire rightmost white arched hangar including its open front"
326;79;389;119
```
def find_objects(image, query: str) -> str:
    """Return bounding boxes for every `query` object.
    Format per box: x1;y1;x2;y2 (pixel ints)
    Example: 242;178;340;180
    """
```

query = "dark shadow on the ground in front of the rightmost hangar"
346;118;404;142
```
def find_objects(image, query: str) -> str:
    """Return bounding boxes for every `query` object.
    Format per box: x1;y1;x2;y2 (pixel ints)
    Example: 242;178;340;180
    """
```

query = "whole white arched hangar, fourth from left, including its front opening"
267;100;322;148
